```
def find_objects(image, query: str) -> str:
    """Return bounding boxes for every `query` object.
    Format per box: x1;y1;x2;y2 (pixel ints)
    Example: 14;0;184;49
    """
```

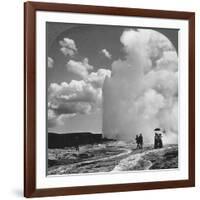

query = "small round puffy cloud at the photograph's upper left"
59;38;78;56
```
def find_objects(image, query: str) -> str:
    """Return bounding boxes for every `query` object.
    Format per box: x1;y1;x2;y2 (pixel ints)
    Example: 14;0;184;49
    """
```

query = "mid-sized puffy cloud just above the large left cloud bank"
66;58;93;78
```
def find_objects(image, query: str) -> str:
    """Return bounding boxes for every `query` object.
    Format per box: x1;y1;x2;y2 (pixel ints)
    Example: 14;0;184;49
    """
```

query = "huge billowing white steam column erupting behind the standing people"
103;29;178;143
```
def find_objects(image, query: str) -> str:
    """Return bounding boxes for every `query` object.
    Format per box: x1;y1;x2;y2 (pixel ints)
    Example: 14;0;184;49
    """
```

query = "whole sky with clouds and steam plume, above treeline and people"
46;23;178;143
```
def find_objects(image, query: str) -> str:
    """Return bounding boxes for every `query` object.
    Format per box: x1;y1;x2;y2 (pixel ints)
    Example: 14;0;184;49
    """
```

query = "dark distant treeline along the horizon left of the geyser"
48;132;112;148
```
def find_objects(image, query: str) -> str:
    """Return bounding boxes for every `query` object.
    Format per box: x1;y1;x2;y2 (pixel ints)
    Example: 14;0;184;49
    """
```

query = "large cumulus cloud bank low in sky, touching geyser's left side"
48;65;111;127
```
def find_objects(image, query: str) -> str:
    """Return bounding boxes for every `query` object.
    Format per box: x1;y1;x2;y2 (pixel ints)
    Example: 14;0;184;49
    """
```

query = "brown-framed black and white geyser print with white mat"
24;2;195;197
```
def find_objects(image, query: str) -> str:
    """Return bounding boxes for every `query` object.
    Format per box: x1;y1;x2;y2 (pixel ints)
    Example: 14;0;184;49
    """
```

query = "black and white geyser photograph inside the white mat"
46;22;178;176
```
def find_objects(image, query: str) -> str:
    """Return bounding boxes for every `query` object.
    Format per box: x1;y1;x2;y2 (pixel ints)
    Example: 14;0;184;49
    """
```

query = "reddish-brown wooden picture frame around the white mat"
24;2;195;197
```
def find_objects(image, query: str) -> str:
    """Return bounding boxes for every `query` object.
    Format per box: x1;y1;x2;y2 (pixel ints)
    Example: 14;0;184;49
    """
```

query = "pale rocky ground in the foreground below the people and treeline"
48;141;178;175
